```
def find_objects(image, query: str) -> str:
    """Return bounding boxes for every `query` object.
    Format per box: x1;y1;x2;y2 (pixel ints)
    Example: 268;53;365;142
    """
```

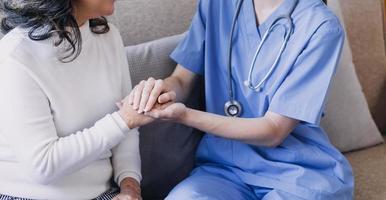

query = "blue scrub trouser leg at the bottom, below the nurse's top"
166;166;305;200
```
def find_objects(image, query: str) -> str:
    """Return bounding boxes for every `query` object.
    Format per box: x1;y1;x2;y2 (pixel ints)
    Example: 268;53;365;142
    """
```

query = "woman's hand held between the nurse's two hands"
117;101;154;129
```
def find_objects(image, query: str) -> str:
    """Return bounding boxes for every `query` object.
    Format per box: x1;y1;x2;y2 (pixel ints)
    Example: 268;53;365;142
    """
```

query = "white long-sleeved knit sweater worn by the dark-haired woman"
0;23;141;200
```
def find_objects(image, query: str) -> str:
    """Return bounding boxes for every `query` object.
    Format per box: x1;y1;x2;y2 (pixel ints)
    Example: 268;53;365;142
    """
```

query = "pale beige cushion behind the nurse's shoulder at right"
322;0;382;152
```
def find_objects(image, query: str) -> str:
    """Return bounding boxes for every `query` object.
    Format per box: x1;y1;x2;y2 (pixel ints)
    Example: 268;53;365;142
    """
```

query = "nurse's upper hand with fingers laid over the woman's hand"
127;78;176;113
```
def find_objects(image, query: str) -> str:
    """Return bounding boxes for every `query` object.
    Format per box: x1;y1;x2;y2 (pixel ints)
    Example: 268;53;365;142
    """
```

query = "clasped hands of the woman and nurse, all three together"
117;78;187;128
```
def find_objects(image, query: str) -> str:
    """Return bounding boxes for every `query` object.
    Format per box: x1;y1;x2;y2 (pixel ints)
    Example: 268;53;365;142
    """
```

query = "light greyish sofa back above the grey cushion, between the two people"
110;0;196;45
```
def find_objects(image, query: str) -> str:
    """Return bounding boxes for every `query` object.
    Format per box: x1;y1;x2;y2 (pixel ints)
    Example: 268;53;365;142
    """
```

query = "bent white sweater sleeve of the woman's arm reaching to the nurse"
0;59;129;184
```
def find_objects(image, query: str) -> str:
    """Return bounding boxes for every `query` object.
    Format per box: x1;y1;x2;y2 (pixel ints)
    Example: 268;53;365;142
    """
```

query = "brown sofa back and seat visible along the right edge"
340;0;386;200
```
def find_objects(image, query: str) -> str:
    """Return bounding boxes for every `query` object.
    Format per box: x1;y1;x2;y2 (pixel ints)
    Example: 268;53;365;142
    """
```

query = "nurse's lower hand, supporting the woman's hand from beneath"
145;103;188;122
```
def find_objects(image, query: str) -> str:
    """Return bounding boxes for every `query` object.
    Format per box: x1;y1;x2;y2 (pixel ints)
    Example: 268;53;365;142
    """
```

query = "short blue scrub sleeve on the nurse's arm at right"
268;18;344;126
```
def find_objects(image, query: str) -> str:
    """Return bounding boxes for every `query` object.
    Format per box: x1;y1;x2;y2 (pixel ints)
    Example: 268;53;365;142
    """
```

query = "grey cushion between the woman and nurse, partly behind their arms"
126;35;204;199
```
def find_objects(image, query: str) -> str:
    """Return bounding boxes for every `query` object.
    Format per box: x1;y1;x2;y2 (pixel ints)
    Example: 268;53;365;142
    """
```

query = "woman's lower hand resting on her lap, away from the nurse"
113;178;142;200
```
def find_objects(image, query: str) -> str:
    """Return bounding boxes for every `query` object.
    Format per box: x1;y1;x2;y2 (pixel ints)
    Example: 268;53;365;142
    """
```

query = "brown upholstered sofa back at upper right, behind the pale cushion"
339;0;386;134
